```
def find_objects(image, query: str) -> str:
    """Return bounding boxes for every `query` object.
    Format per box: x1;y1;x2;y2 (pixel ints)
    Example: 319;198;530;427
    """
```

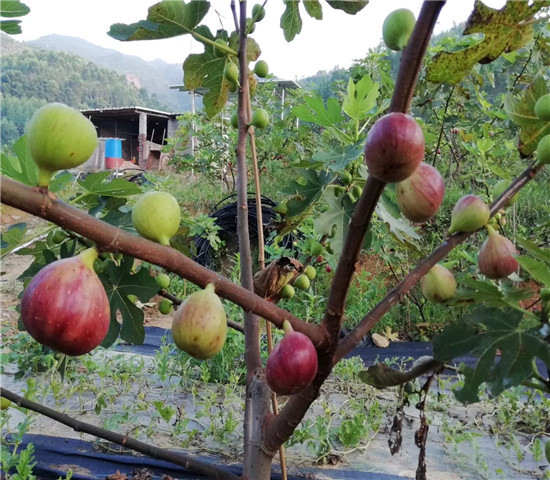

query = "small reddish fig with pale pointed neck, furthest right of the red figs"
477;225;519;279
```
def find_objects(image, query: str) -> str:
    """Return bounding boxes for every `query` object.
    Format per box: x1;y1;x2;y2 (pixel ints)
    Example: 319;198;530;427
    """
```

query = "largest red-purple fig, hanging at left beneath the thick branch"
21;248;111;356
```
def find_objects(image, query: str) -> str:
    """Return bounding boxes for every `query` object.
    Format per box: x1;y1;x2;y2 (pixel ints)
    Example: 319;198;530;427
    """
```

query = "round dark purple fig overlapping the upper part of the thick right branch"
365;112;424;183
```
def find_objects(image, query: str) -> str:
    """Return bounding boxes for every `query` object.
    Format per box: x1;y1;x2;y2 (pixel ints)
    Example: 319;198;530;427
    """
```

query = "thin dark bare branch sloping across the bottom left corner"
0;387;241;480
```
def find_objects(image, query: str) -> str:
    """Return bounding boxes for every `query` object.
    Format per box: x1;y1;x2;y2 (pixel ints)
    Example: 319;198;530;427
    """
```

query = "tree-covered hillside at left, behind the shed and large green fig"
0;36;174;145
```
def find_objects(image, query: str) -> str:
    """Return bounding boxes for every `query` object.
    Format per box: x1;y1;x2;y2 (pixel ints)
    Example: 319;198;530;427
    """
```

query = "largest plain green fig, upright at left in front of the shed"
27;103;98;187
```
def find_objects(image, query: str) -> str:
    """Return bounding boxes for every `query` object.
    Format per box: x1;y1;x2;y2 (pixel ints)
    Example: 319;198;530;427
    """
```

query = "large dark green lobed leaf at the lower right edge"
433;309;550;403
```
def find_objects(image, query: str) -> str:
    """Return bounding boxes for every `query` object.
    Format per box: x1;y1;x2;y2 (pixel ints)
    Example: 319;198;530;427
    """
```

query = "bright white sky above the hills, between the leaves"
14;0;504;80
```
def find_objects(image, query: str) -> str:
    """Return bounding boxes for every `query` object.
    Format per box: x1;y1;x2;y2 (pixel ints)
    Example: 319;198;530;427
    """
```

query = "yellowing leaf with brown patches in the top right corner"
426;0;550;84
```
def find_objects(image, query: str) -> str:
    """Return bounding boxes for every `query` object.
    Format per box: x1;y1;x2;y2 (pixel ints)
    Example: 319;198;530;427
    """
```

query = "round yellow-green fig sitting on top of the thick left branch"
132;192;181;245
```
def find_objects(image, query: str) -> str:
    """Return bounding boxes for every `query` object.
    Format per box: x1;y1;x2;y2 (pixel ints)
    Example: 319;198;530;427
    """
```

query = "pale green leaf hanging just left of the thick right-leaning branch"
313;188;355;257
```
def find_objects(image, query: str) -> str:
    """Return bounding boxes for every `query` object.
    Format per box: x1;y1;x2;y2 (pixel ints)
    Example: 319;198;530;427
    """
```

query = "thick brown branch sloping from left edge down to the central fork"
0;177;325;345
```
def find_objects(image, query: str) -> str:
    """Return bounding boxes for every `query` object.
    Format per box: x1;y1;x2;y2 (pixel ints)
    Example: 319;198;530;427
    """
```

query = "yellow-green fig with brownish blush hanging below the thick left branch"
172;283;227;360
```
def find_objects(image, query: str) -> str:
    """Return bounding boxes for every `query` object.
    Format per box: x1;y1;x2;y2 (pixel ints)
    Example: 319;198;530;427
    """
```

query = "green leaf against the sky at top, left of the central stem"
107;0;210;42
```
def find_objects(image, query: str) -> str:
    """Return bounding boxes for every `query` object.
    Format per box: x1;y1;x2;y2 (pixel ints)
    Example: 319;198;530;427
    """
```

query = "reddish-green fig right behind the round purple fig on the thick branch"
395;162;445;223
